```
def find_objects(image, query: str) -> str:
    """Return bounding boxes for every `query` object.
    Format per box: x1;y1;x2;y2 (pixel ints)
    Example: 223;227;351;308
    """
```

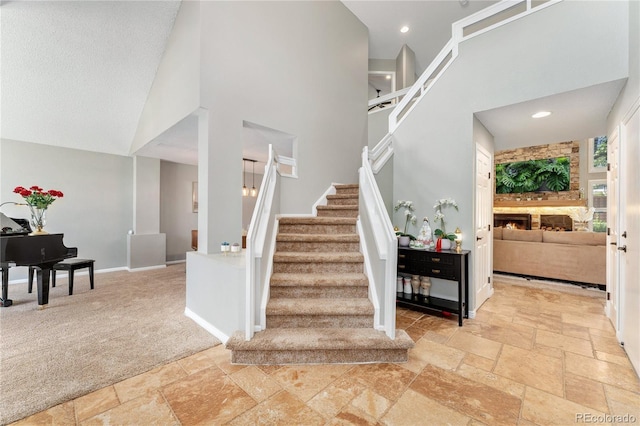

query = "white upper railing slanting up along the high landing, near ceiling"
369;0;562;173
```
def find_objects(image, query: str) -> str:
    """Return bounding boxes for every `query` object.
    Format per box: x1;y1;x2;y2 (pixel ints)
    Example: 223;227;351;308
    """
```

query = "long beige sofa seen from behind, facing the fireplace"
493;228;606;286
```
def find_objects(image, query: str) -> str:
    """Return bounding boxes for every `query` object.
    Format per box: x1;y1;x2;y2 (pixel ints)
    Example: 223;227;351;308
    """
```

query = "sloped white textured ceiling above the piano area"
0;1;180;155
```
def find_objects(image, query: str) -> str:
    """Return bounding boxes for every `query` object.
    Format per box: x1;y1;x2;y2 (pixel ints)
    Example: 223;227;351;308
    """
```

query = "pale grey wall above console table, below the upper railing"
393;2;629;309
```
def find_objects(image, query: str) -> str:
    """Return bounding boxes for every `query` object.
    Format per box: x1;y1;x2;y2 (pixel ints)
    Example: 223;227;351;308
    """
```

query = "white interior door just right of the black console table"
473;144;493;311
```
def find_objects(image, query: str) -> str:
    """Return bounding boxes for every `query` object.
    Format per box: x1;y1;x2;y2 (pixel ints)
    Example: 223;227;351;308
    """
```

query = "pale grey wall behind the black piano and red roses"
0;139;133;281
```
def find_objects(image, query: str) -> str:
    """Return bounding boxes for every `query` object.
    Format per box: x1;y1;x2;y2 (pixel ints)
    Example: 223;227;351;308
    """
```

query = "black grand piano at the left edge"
0;213;78;309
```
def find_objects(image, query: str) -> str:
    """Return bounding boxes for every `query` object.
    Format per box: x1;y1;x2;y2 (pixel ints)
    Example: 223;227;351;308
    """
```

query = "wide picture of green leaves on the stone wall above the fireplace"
496;157;570;194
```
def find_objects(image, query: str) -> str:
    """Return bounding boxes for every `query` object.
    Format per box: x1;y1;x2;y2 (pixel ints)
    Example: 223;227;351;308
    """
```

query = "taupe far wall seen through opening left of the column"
160;161;198;261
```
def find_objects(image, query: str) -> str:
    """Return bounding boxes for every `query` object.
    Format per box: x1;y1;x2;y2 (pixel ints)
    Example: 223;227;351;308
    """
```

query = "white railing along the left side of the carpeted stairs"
245;145;297;340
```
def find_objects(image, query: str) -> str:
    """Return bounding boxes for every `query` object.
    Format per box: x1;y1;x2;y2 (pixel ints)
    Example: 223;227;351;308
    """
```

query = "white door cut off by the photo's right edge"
618;104;640;371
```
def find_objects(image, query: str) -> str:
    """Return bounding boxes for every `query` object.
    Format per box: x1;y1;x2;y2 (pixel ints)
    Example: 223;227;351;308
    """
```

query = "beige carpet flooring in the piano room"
0;264;220;425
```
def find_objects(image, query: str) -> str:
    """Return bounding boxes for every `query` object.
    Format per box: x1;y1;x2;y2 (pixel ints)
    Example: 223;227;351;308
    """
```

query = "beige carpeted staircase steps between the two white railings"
226;185;414;364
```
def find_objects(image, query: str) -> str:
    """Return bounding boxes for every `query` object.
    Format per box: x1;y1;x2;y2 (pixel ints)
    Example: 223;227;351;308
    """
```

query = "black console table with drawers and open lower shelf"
396;247;469;326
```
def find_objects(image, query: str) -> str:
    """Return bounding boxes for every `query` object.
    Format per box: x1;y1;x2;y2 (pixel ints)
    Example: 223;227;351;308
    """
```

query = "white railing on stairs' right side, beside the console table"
359;147;398;339
